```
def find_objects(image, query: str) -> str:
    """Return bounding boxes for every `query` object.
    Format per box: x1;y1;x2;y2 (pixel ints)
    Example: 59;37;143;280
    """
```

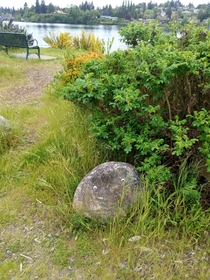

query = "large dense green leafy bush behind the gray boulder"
60;23;210;205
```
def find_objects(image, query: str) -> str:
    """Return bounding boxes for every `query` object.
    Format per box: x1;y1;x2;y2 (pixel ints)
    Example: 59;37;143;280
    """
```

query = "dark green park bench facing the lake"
0;31;40;59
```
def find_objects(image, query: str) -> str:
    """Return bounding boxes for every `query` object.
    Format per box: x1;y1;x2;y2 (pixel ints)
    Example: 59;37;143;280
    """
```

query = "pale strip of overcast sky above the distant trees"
3;0;210;9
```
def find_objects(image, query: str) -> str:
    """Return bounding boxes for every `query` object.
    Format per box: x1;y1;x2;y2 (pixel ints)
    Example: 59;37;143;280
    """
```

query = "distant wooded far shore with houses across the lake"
0;0;210;24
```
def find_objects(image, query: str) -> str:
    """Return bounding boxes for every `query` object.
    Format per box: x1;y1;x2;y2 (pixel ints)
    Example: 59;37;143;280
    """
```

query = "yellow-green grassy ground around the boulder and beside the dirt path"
0;49;210;280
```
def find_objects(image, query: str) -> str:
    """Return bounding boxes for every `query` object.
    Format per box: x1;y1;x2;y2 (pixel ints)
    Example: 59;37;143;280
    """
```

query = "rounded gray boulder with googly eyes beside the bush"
73;162;141;219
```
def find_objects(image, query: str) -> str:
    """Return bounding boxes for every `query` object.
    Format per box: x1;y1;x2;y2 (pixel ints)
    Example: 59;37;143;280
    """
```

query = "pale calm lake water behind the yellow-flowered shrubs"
15;22;127;51
